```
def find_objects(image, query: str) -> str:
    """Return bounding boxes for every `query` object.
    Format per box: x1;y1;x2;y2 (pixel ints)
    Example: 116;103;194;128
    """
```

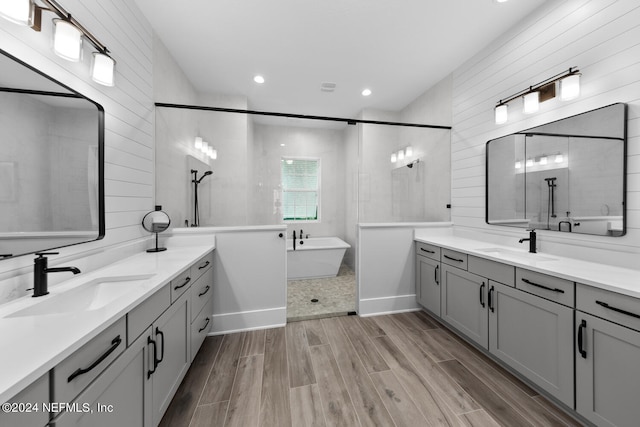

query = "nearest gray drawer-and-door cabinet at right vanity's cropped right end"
575;285;640;427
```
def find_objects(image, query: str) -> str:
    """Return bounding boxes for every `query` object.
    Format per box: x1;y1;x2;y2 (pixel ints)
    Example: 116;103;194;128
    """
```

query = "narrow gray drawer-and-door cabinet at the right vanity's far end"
416;243;440;317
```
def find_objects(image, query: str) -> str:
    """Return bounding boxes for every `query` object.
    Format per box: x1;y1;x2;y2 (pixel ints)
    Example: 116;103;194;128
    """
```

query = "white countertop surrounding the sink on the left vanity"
0;243;215;403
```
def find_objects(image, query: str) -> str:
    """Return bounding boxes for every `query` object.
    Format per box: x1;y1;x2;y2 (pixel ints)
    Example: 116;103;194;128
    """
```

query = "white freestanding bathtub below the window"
287;237;351;280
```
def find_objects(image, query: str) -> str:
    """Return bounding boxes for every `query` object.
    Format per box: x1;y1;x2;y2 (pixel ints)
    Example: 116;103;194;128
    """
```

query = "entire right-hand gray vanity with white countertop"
415;234;640;426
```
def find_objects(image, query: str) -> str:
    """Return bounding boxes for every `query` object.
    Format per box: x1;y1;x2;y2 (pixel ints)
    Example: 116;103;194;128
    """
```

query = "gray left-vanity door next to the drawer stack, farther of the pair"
151;293;191;426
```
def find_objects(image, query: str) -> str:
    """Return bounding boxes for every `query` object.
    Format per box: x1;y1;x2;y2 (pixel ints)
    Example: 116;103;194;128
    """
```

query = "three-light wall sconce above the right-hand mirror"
494;67;580;125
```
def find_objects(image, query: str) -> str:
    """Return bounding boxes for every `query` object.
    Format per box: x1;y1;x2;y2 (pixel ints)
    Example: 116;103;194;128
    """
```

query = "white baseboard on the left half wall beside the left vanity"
208;307;287;335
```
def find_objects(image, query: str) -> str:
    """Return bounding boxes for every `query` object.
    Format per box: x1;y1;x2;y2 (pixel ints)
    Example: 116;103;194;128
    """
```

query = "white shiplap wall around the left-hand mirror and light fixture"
0;0;154;277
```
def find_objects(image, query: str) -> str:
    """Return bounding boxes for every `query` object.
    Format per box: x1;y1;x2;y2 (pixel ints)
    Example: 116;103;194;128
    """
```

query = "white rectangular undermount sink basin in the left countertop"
5;274;153;317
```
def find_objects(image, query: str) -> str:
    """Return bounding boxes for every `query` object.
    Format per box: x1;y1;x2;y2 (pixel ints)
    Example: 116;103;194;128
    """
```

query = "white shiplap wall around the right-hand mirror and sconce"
451;0;640;268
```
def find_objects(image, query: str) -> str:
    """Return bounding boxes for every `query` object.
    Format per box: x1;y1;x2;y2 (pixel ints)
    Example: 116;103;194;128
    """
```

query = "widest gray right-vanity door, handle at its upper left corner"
489;281;573;407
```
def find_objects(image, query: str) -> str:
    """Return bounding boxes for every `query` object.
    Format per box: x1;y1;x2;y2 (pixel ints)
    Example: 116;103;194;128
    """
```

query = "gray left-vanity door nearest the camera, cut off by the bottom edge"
55;329;153;427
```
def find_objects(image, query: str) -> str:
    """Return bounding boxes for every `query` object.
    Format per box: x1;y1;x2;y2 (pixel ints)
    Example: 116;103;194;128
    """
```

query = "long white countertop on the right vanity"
414;230;640;298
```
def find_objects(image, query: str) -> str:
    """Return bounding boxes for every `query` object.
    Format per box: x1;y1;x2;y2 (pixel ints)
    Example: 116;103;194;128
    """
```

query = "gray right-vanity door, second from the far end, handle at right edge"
440;264;489;349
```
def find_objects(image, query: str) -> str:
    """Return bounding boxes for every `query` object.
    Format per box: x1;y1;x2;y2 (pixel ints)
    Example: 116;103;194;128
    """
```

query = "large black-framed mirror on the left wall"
0;50;105;260
